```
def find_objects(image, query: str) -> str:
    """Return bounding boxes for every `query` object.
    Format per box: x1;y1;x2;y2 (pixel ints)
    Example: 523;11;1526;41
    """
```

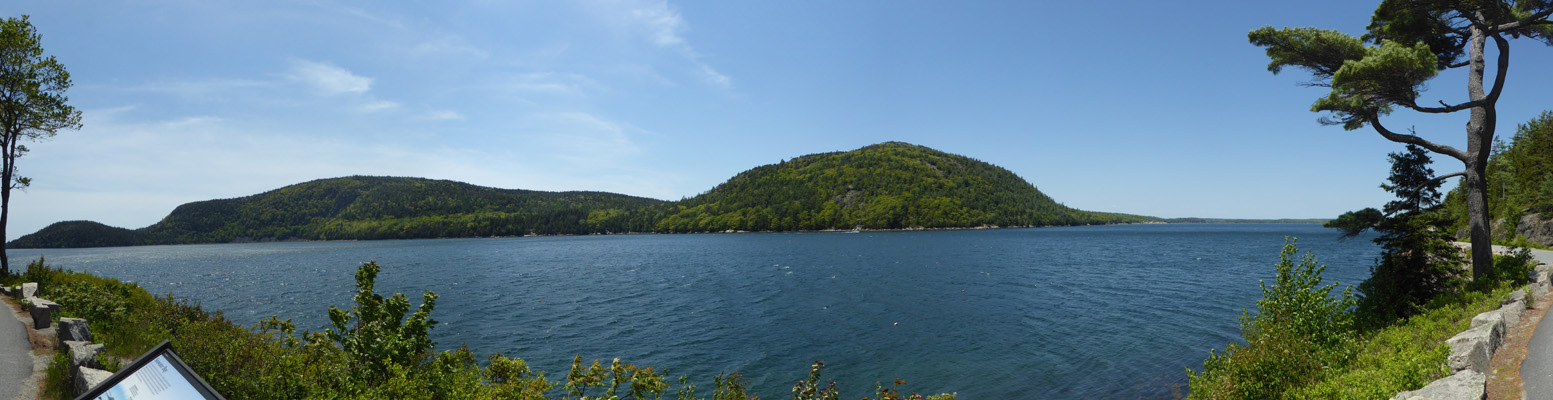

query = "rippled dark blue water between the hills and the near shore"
9;225;1379;398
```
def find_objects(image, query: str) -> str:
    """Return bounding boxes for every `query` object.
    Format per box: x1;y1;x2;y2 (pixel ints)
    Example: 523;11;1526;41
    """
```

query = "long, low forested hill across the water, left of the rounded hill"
9;177;663;248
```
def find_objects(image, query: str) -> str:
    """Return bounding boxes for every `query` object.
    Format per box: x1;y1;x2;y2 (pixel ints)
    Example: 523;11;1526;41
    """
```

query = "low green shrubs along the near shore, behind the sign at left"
3;259;955;400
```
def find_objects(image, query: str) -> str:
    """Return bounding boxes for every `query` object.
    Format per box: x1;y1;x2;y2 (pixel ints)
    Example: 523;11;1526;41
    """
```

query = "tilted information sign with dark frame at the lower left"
76;341;227;400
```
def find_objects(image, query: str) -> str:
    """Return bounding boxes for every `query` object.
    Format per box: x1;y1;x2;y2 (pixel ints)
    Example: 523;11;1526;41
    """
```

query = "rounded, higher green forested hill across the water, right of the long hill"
657;143;1155;233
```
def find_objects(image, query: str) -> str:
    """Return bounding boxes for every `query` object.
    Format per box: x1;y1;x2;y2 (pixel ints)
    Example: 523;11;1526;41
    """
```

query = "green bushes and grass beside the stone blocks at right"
1188;241;1530;400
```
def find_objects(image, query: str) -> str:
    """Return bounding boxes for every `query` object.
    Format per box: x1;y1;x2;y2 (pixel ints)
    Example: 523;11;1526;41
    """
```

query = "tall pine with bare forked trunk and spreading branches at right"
1249;0;1553;276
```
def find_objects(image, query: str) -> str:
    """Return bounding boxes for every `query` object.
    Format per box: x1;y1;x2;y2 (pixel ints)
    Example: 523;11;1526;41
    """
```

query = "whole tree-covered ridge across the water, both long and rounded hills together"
9;143;1157;248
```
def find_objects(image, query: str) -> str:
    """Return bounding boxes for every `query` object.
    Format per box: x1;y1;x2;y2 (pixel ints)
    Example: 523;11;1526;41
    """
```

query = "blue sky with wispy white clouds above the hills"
0;0;1553;240
